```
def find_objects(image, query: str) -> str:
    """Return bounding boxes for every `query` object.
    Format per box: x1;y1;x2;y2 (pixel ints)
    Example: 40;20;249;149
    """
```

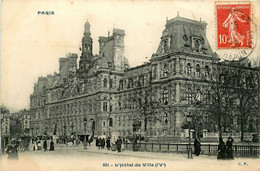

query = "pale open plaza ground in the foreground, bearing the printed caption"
1;145;260;171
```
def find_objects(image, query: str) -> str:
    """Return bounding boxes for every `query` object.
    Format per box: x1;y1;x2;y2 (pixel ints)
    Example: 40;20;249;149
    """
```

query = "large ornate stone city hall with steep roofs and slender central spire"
30;17;254;140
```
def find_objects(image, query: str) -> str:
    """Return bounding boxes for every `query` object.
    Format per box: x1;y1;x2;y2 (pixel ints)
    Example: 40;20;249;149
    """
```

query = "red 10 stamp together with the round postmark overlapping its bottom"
215;1;256;60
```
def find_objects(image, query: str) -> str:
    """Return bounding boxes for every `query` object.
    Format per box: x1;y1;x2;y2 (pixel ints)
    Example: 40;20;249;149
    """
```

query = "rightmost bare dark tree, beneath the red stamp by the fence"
230;64;259;142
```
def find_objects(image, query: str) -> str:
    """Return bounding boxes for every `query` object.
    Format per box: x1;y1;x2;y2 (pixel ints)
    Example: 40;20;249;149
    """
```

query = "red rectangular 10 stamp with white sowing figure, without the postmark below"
216;2;252;49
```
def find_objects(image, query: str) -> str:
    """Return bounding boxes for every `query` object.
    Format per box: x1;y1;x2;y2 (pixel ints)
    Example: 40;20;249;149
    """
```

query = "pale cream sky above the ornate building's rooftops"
0;0;260;112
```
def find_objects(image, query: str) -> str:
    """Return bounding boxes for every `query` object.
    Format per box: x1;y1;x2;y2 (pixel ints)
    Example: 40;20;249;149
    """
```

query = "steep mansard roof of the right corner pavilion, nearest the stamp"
156;17;213;57
